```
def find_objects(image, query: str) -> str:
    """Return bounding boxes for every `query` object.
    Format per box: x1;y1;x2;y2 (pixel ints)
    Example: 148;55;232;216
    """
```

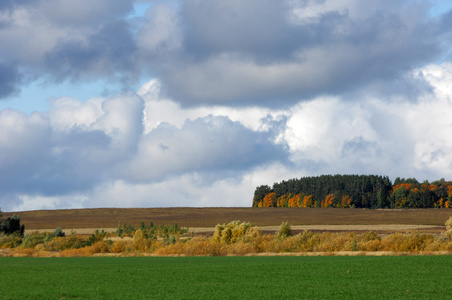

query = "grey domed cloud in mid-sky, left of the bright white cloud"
124;115;285;181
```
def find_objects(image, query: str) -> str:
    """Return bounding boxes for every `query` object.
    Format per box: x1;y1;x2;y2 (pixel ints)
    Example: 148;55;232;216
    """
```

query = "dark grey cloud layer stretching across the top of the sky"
0;0;451;108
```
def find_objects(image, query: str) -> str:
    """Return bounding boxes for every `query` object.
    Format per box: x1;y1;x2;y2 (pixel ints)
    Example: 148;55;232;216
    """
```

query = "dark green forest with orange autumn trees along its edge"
253;175;452;209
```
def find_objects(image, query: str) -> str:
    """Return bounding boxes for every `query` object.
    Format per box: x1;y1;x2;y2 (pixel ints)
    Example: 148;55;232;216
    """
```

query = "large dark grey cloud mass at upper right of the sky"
159;0;441;106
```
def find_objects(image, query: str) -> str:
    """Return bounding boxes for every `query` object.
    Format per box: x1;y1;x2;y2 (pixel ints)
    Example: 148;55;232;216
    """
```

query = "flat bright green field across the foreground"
0;256;452;299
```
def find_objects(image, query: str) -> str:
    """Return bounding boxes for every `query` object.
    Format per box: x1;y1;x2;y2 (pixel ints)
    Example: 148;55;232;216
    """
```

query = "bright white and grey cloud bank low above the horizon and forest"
0;63;452;210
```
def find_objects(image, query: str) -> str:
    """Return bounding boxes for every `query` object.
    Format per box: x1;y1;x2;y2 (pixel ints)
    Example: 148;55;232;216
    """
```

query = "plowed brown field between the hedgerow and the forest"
4;208;452;233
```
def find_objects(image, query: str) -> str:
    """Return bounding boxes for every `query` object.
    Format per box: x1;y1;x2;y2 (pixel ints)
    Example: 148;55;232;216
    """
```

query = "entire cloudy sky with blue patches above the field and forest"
0;0;452;211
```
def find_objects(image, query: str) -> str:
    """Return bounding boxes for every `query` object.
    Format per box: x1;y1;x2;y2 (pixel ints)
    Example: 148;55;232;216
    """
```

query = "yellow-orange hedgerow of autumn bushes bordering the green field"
0;219;452;256
